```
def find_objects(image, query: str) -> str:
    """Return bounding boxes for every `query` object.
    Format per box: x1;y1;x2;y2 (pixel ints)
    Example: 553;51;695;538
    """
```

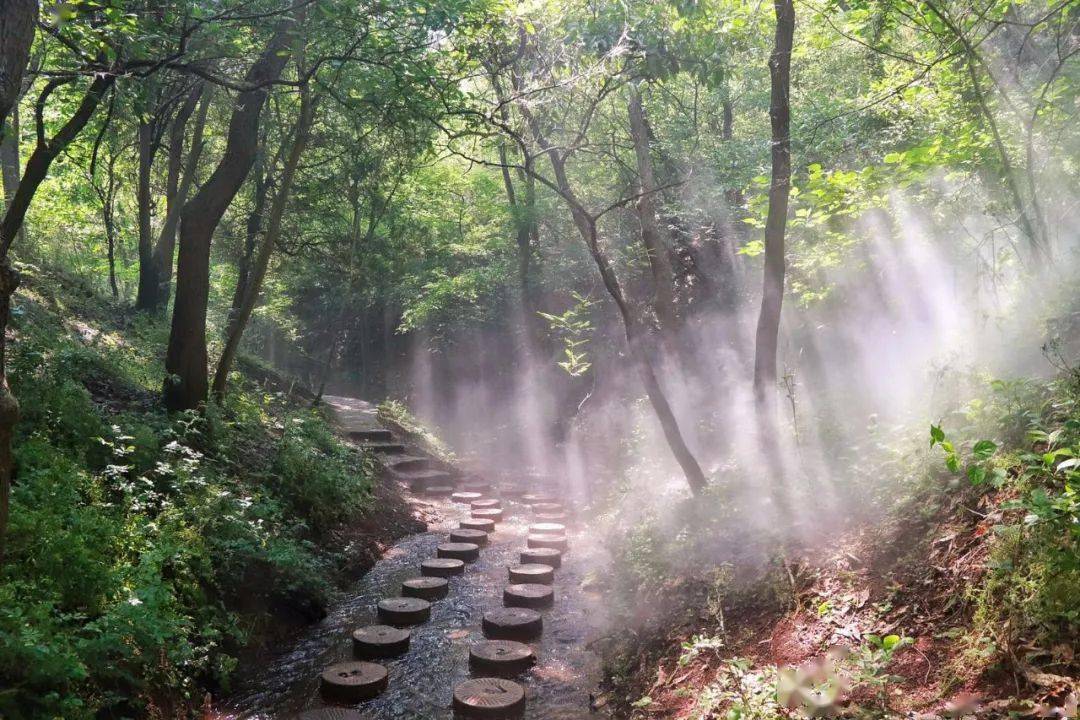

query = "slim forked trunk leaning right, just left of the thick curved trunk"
147;83;211;311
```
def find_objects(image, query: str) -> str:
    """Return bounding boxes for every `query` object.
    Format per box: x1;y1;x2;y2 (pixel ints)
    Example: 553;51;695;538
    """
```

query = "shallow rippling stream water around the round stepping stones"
221;492;606;720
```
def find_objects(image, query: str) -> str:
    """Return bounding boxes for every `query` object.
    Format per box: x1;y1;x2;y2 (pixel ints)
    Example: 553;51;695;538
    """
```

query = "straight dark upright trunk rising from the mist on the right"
754;0;795;440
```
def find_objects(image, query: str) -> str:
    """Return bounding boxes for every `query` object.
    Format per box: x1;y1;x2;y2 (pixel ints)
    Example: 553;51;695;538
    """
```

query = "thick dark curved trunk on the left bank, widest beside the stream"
162;18;295;410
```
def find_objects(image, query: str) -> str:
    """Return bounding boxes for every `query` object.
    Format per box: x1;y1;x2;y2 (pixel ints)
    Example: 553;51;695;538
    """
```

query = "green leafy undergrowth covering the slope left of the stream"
0;269;370;720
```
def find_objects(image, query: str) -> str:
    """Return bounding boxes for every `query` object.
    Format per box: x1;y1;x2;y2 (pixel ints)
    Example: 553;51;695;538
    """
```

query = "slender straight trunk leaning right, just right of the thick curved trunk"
213;85;313;400
